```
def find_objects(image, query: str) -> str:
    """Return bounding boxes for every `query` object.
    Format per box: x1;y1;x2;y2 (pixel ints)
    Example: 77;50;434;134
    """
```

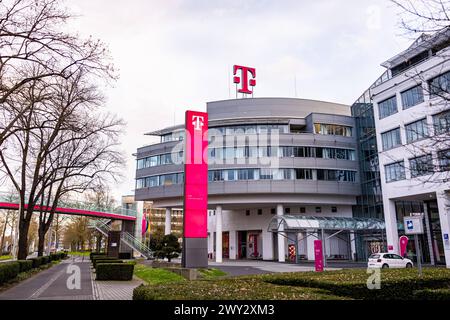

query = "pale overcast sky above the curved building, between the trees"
67;0;411;197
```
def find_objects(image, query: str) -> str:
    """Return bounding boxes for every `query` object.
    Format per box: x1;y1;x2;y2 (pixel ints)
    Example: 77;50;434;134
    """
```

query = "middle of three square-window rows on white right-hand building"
381;111;450;150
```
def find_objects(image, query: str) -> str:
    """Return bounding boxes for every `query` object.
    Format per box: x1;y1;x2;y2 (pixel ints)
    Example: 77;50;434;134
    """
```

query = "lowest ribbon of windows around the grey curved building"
136;168;356;189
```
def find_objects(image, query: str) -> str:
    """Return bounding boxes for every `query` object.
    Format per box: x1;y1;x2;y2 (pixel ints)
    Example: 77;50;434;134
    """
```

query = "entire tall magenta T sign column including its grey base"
182;111;208;268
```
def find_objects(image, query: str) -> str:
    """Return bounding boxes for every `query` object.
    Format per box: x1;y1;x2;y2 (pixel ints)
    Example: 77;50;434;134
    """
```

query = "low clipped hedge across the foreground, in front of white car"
133;268;450;300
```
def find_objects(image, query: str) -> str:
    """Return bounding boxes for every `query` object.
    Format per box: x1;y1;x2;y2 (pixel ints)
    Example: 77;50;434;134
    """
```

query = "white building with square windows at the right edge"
354;29;450;267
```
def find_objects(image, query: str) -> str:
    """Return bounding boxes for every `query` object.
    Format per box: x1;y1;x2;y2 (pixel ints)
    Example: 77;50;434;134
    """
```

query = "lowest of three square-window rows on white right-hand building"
384;149;450;182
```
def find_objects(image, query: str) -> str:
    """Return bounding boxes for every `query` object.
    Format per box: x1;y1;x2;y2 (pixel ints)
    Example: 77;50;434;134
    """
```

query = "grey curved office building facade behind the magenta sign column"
135;98;360;261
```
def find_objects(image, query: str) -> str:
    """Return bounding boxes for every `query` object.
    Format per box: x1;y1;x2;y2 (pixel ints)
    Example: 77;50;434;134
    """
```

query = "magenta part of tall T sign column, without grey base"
184;111;208;238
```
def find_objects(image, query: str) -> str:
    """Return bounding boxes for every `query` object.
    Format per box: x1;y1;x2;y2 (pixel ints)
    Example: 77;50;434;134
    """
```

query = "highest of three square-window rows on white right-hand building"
378;71;450;119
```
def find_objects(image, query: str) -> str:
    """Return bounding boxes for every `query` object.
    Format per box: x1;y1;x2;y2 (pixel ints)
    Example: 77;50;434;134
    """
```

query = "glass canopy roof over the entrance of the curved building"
267;215;386;232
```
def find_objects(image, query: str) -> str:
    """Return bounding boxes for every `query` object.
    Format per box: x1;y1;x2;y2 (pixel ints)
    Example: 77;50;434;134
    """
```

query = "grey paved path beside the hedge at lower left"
0;257;94;300
